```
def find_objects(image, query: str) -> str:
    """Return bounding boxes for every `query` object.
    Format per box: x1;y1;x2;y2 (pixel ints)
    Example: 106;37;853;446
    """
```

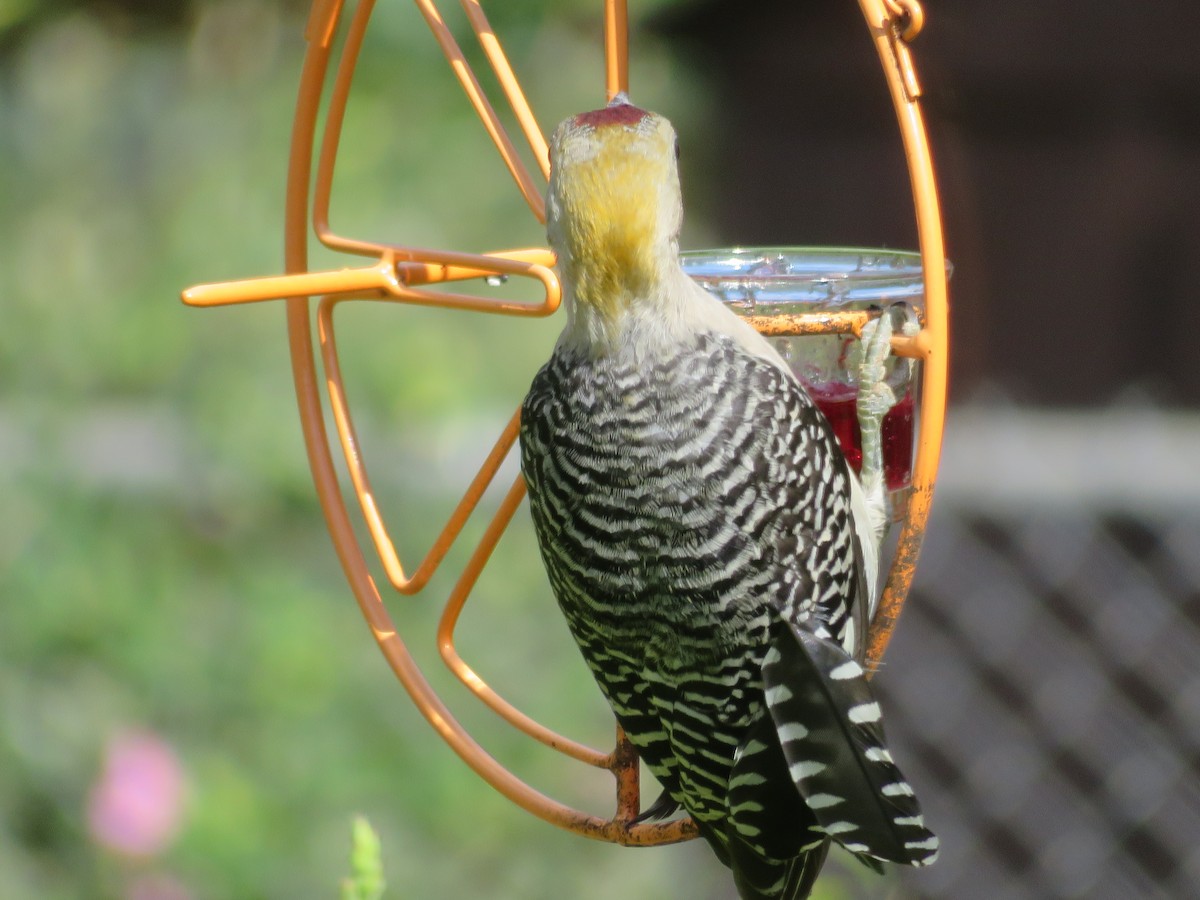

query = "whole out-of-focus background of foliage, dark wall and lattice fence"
0;0;1200;900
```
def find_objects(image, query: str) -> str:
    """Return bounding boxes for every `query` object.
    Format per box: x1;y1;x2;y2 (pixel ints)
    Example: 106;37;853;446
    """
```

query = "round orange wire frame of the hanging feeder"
182;0;948;845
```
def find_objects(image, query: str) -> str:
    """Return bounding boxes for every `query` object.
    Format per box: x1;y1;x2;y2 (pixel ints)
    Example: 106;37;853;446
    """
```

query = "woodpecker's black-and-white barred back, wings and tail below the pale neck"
522;332;936;898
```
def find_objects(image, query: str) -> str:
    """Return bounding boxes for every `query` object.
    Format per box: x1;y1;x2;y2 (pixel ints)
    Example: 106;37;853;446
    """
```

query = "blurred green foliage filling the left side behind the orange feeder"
0;0;884;900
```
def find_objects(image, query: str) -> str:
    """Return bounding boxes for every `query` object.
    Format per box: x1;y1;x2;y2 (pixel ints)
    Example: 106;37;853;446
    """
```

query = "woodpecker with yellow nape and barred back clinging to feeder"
521;95;937;900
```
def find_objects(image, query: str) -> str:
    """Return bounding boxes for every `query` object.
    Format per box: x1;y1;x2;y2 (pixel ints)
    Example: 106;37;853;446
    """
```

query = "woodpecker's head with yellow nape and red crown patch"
546;94;683;322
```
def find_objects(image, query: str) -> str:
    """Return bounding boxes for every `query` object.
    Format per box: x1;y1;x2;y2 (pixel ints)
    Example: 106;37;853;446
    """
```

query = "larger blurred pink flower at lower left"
88;732;184;857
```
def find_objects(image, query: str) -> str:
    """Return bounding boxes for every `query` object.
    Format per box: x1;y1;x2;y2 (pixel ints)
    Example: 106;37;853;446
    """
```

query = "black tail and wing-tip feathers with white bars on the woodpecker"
722;617;938;900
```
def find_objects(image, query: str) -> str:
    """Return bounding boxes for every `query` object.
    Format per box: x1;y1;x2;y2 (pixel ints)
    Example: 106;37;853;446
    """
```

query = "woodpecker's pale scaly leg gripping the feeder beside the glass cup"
851;305;918;544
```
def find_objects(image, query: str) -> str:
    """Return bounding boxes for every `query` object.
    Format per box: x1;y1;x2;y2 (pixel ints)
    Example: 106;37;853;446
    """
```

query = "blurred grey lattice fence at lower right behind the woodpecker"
877;412;1200;900
